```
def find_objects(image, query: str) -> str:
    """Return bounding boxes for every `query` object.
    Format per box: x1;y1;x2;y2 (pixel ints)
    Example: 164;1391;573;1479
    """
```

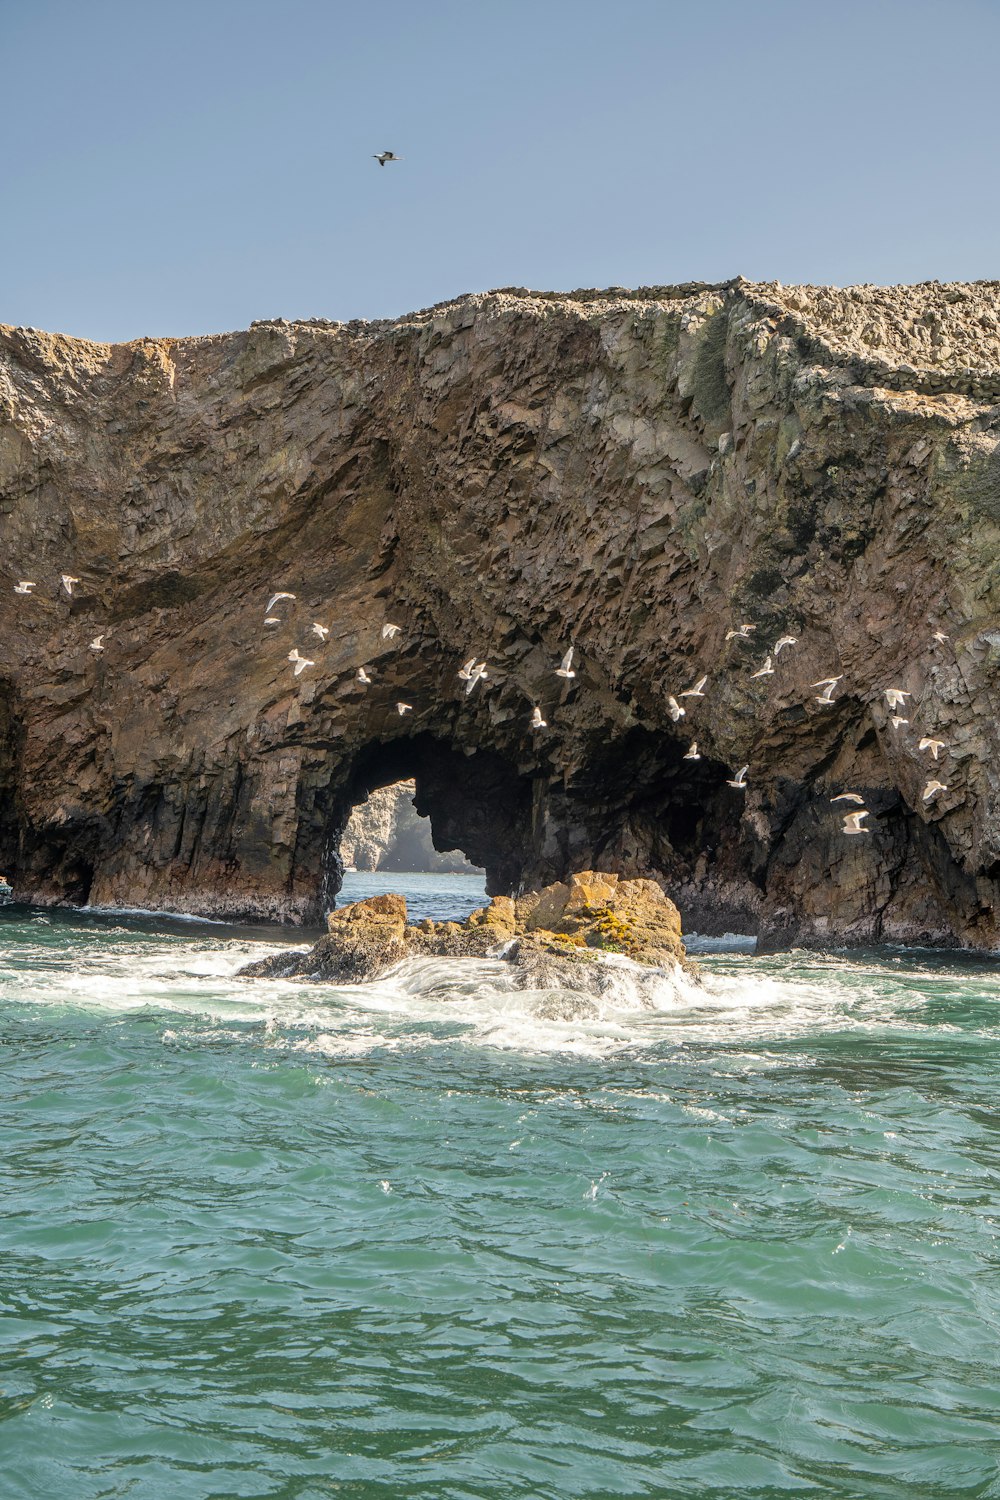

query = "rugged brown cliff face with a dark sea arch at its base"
0;282;1000;947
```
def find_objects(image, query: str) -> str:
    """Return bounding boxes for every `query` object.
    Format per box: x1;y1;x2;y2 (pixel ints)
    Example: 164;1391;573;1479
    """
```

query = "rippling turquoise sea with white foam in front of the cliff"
0;882;1000;1500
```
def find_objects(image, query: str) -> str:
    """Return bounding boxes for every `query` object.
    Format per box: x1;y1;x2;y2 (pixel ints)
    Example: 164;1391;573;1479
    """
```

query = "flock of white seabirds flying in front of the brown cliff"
13;570;949;834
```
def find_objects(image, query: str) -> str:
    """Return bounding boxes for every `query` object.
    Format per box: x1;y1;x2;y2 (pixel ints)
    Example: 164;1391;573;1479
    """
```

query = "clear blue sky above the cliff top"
0;0;1000;339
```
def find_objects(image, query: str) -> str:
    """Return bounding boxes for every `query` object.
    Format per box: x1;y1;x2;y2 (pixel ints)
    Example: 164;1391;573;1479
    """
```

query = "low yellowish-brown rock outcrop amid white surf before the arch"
240;870;688;995
